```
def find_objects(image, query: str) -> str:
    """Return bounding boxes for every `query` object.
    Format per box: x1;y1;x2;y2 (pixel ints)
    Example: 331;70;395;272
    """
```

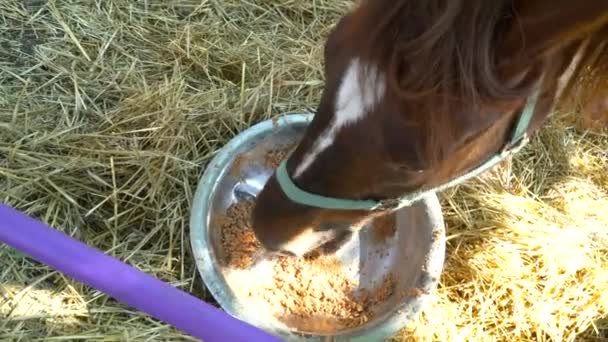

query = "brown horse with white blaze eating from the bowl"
253;0;608;256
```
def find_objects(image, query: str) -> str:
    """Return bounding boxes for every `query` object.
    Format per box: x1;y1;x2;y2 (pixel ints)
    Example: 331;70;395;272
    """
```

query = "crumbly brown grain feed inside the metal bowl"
218;148;395;332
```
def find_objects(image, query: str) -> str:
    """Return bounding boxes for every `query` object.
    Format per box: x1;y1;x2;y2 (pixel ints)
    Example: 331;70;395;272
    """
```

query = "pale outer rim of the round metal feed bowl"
189;113;446;342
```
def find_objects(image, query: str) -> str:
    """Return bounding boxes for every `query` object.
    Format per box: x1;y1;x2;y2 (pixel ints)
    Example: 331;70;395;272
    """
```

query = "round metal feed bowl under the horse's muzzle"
190;114;445;341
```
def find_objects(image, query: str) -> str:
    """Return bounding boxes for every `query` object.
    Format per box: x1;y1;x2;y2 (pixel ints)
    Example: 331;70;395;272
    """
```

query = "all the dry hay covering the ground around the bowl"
0;0;608;341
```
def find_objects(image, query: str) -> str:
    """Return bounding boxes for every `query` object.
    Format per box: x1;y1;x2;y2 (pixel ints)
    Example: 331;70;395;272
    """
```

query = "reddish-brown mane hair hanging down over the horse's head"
361;0;608;168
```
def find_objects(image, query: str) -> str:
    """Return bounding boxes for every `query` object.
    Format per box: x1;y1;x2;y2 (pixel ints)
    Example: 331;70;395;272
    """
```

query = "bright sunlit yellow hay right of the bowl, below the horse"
405;111;608;341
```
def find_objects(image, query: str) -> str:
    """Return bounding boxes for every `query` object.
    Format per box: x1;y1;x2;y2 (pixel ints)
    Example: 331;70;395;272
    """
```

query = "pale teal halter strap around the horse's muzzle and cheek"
276;92;539;211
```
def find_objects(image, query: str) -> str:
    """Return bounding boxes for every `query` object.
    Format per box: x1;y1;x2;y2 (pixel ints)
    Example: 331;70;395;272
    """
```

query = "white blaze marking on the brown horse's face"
294;58;386;178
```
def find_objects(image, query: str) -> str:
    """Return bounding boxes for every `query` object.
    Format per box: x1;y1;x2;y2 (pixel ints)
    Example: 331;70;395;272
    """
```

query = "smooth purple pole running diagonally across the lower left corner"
0;204;280;342
